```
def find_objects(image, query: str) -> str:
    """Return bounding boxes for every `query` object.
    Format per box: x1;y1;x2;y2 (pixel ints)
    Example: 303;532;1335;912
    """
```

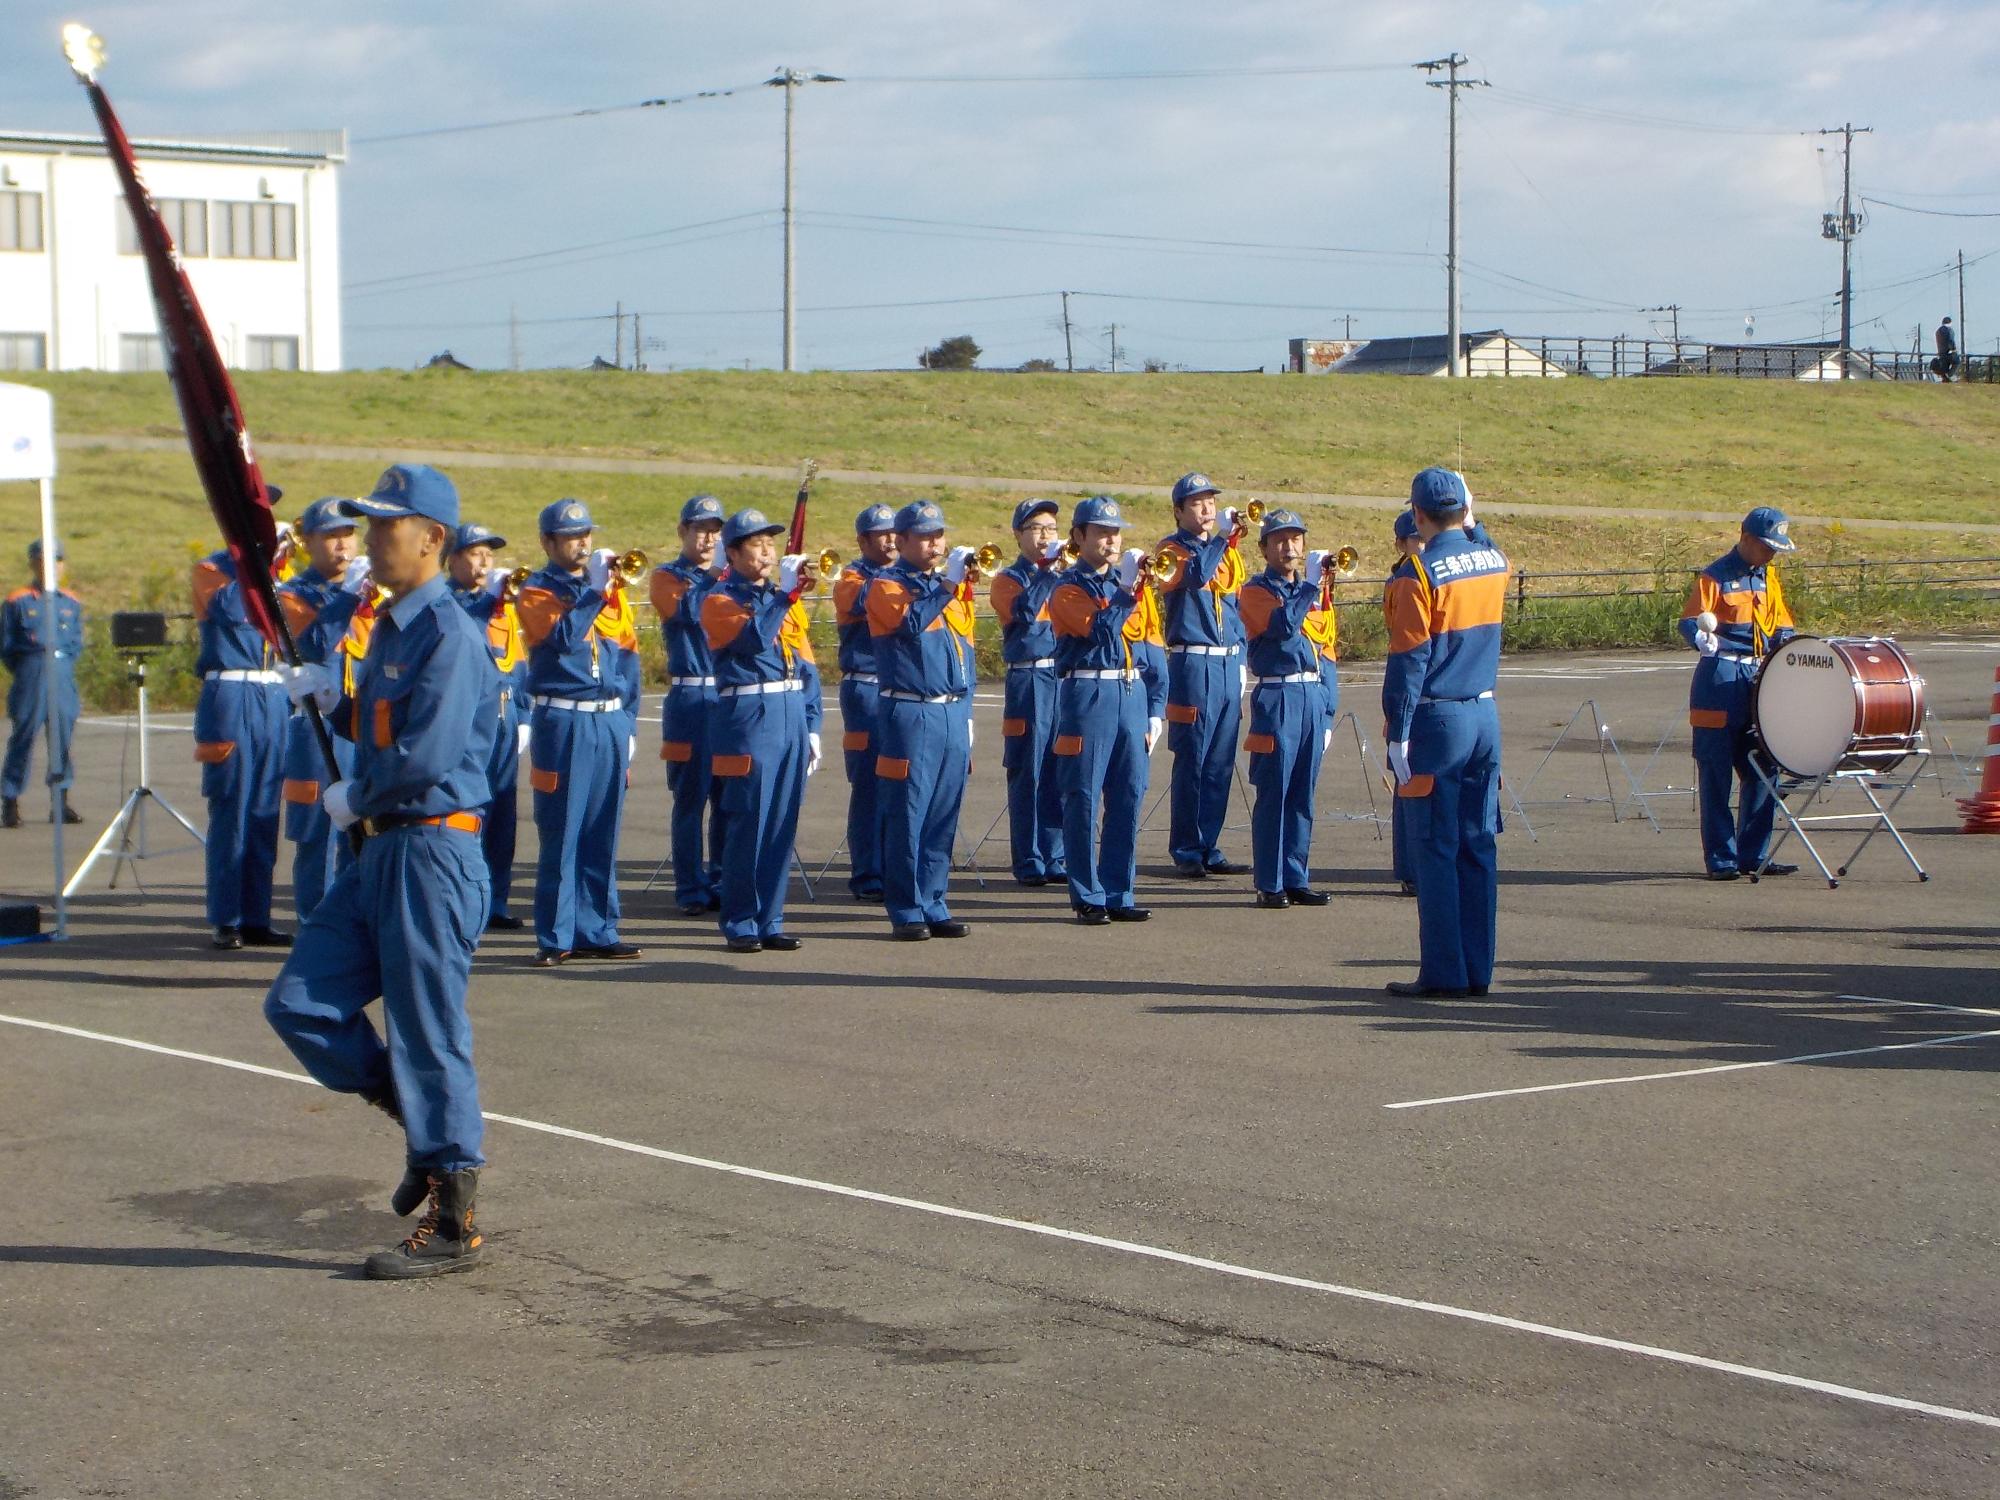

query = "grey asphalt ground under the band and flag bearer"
0;640;2000;1500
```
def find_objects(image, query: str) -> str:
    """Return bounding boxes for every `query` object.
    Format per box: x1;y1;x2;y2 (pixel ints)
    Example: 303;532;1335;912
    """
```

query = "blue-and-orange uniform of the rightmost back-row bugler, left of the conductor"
1160;530;1246;866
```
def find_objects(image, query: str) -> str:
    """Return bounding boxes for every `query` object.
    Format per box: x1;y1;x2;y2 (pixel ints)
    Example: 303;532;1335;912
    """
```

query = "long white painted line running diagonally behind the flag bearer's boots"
0;1014;2000;1430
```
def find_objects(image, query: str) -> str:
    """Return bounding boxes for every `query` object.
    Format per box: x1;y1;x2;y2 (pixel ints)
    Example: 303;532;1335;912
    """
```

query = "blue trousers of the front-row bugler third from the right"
876;698;972;926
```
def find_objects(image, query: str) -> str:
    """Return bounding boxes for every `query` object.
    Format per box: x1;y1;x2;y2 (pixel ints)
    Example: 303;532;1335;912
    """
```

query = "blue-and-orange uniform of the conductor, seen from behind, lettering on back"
1382;530;1508;990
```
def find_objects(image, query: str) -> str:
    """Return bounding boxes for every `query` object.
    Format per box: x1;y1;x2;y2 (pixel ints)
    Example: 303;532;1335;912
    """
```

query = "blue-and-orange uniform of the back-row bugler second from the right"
988;556;1068;880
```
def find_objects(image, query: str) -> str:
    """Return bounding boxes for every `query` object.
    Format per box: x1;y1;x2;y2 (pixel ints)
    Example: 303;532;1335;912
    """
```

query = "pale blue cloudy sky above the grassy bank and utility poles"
0;0;2000;370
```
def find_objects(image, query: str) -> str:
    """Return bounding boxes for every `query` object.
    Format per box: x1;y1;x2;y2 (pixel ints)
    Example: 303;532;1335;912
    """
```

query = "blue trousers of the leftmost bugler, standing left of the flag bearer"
194;682;290;928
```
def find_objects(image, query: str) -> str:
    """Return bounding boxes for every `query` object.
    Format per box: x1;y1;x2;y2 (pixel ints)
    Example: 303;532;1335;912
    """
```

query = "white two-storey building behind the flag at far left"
0;130;348;370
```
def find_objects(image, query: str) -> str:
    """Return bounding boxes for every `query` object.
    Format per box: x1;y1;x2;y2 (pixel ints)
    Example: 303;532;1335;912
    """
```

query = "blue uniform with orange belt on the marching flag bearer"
264;578;500;1172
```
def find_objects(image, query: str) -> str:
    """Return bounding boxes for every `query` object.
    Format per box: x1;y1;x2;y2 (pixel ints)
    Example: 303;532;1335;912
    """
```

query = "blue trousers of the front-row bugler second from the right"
1056;678;1150;906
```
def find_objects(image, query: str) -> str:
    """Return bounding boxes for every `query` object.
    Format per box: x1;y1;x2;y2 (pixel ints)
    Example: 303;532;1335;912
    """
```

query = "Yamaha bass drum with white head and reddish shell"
1750;636;1924;776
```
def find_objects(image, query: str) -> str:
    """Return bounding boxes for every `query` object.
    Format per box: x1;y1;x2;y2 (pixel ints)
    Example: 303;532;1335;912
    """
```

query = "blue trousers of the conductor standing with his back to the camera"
1396;698;1500;990
